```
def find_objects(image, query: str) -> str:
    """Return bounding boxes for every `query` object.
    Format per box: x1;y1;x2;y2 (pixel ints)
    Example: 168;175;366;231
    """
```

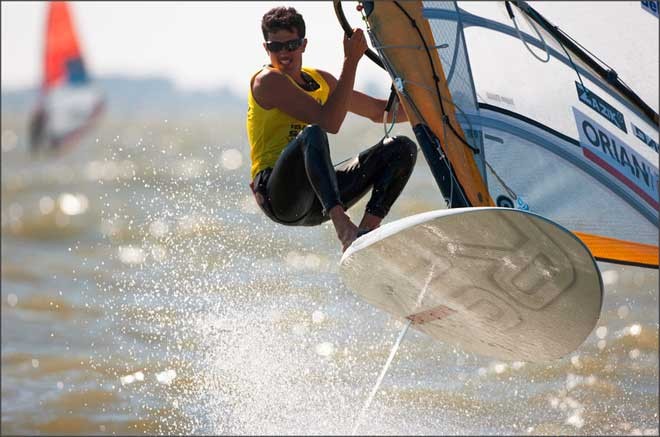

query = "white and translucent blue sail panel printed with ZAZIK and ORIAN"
424;2;658;244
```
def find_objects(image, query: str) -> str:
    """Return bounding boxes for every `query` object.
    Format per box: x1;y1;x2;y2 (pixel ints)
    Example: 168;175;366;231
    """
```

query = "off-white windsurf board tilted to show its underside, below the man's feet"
340;207;603;362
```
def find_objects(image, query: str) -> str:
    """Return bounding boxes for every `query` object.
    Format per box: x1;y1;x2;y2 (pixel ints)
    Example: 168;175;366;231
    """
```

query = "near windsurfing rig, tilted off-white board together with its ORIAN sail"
335;0;660;361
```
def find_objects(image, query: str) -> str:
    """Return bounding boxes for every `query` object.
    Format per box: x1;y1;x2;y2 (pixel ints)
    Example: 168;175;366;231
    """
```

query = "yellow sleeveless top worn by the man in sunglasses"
246;67;330;179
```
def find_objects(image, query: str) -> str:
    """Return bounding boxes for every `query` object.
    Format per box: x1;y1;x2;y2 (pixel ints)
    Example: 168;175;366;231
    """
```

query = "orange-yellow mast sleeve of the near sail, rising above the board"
368;1;495;206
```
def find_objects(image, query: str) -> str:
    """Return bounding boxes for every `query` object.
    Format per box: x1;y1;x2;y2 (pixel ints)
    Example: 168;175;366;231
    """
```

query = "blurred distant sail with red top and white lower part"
30;2;104;151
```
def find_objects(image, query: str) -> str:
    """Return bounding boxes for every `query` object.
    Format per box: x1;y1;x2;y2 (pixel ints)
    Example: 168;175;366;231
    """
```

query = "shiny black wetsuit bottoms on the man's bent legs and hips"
253;125;417;226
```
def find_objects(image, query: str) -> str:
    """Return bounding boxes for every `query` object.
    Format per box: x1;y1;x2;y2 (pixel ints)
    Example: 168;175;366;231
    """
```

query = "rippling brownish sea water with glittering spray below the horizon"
1;114;658;435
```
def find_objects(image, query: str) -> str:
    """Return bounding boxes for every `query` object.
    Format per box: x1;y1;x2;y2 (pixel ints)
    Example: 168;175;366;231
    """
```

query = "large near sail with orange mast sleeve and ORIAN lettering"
348;1;659;268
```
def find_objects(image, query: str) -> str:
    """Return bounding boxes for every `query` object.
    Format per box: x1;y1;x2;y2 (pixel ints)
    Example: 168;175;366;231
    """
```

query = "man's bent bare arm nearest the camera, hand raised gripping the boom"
252;30;367;133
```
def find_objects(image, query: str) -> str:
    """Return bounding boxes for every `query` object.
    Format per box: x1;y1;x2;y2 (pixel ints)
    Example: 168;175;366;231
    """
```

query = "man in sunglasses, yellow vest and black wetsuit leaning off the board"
247;7;417;250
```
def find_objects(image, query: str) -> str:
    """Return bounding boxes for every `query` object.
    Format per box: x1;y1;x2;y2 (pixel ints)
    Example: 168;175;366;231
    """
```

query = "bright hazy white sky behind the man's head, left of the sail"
1;1;388;91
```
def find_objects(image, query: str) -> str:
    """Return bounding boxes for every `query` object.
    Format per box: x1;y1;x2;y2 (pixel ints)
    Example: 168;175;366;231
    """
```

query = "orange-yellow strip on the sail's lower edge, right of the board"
574;232;658;269
